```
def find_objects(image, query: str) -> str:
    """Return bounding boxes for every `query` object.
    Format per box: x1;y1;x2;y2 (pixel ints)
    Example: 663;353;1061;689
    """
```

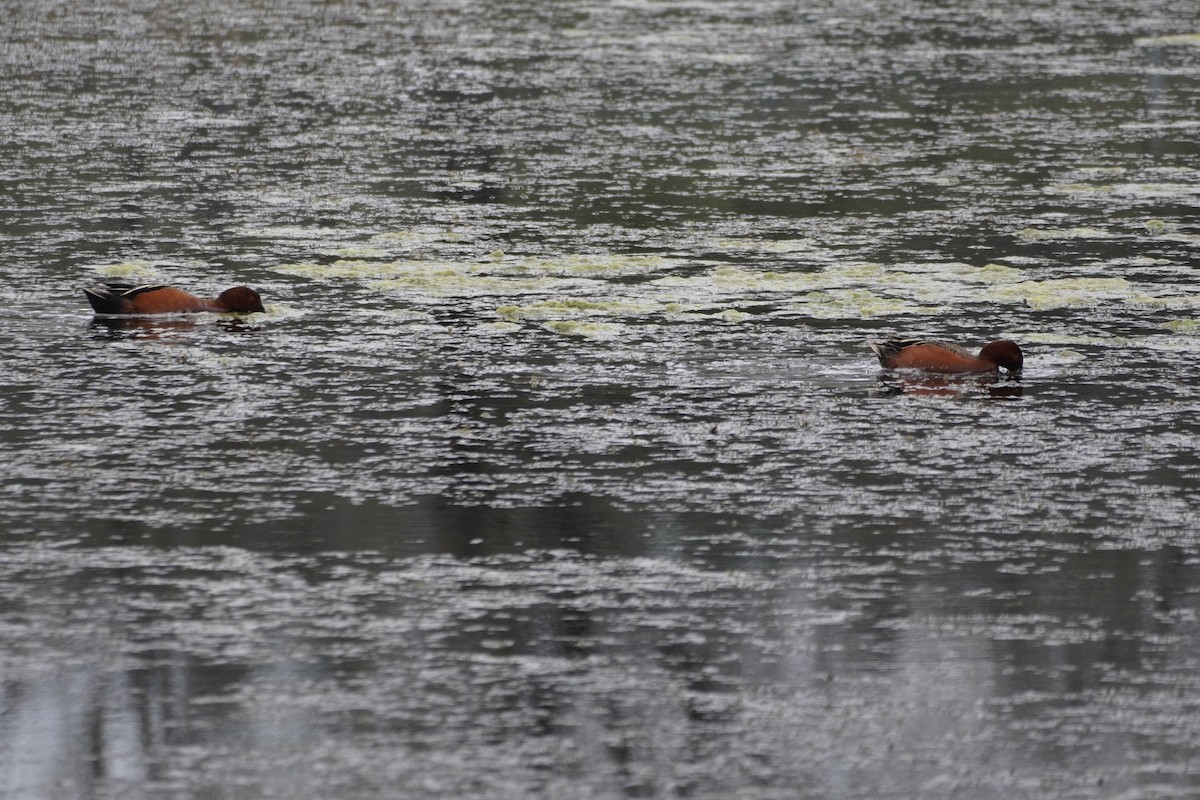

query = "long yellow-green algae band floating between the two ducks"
276;255;1152;321
